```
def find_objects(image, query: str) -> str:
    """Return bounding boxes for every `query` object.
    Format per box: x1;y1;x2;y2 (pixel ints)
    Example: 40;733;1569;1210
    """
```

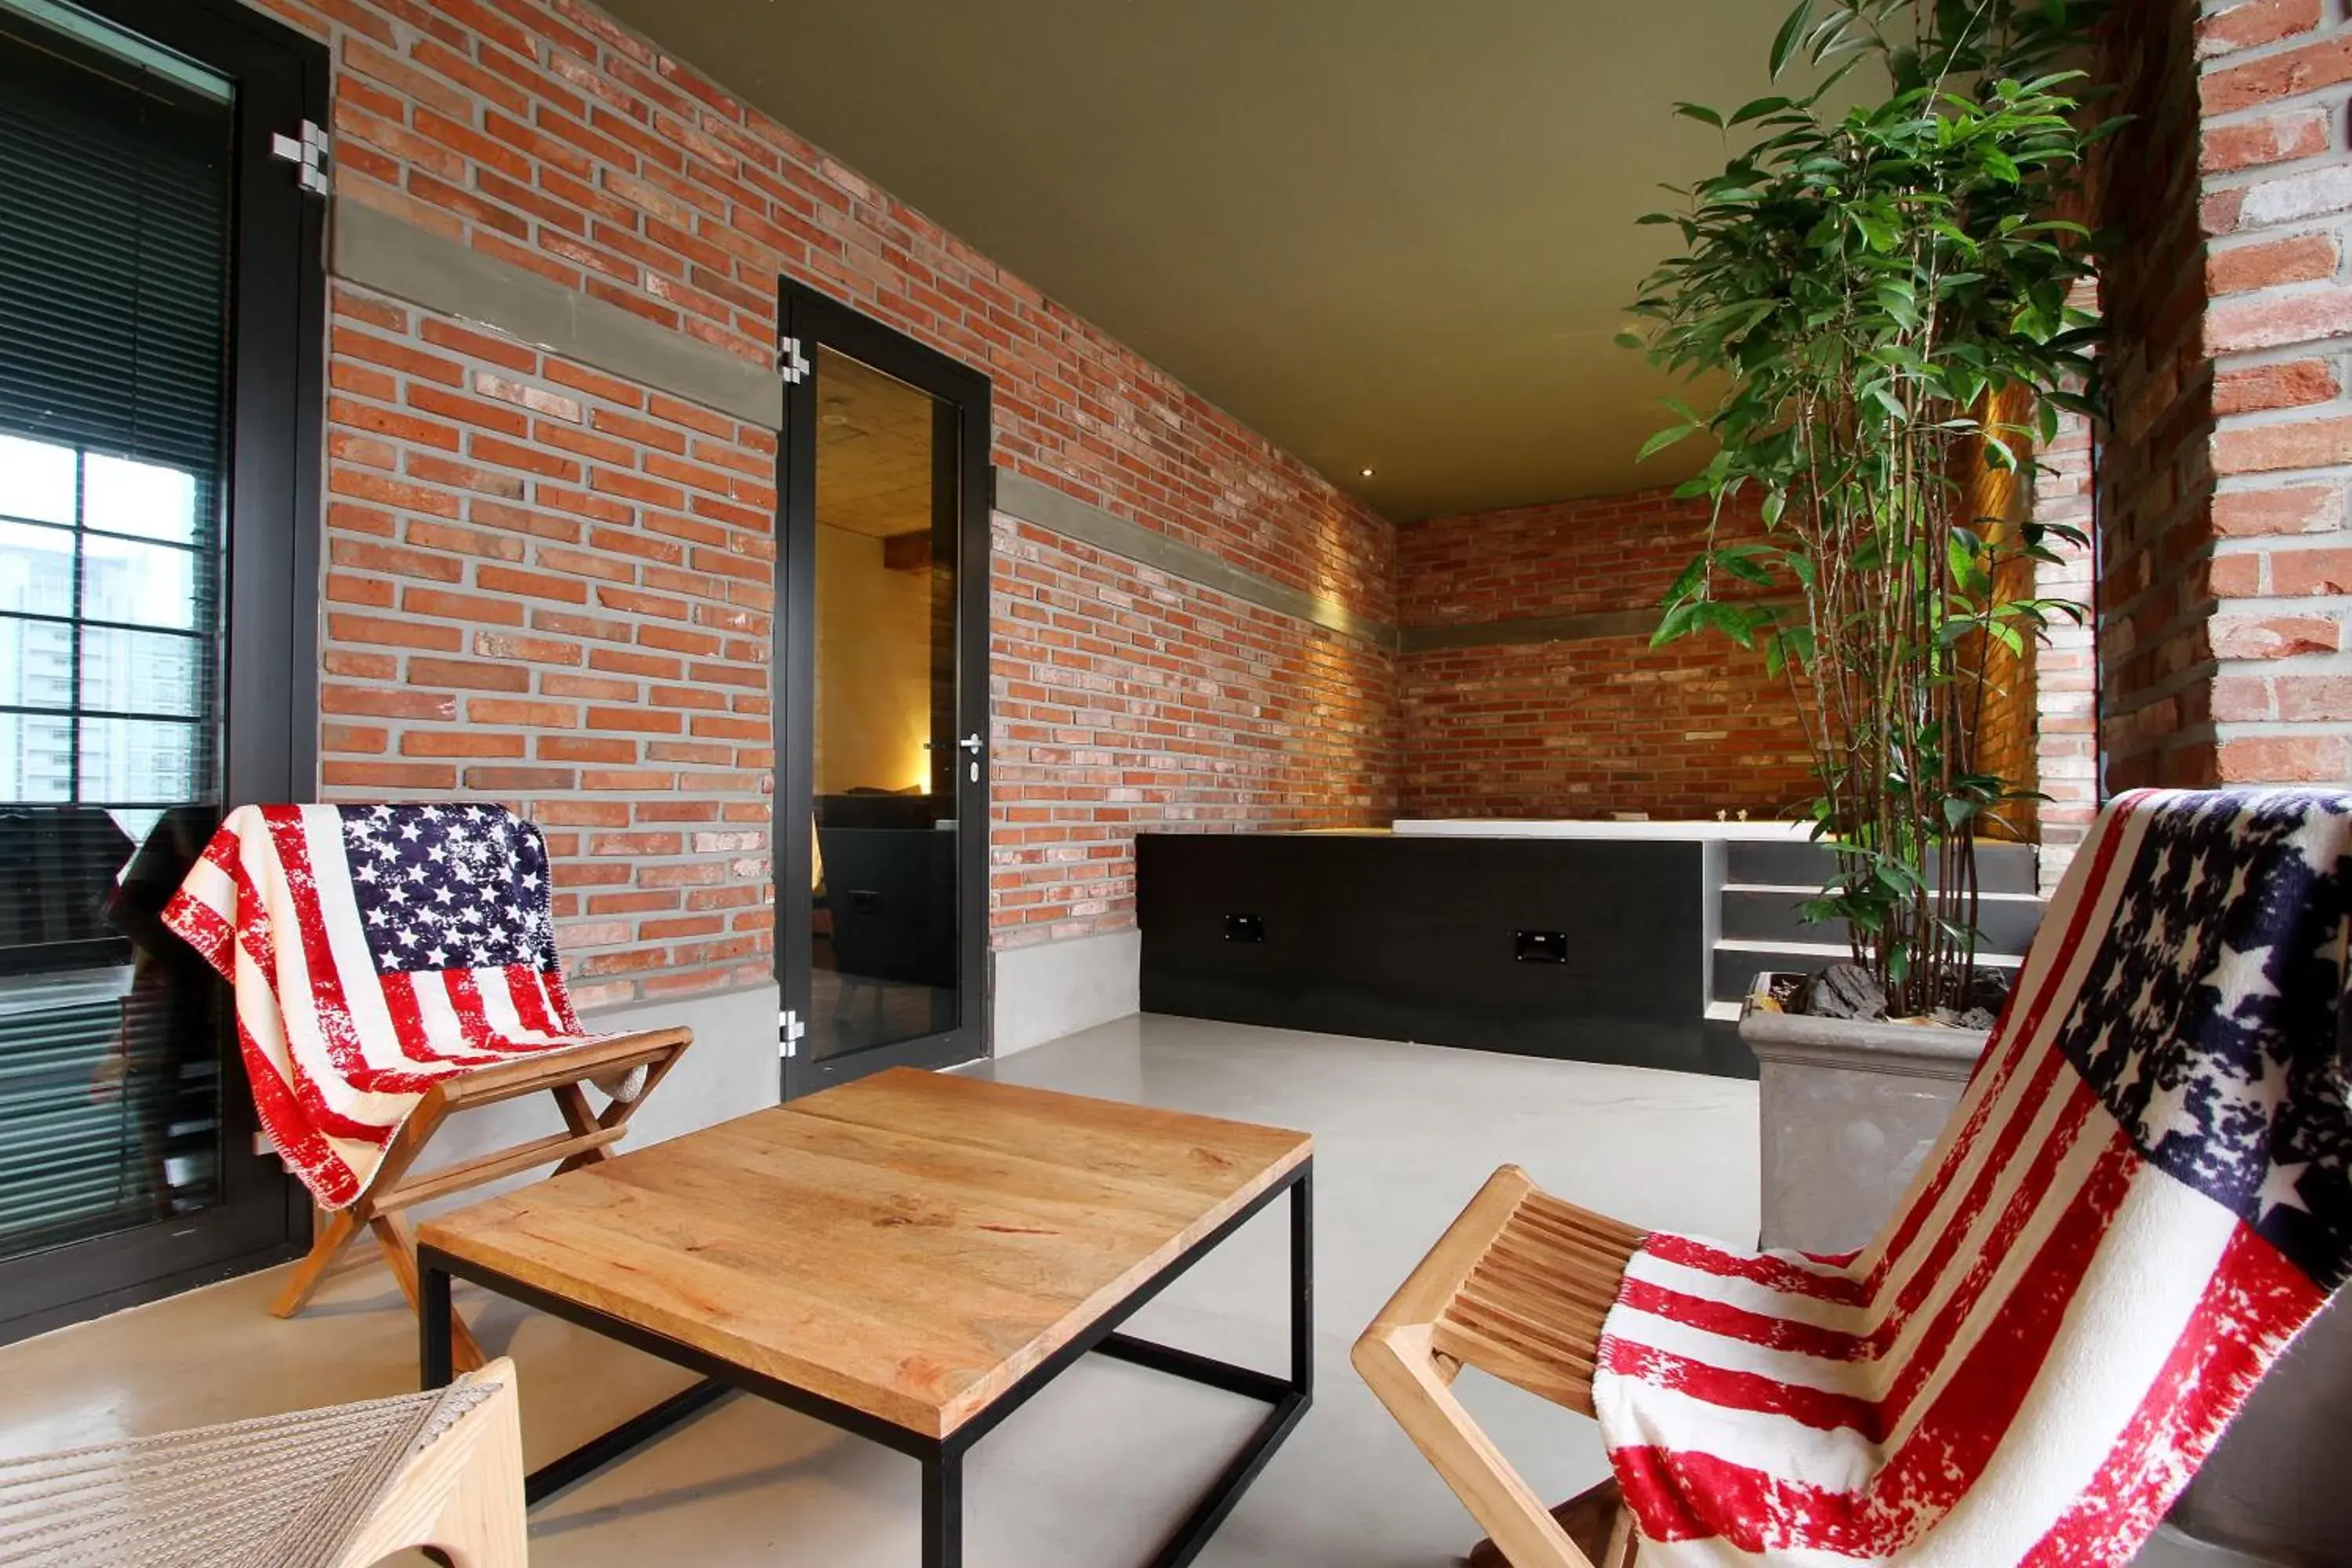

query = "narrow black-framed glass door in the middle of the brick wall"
776;285;990;1095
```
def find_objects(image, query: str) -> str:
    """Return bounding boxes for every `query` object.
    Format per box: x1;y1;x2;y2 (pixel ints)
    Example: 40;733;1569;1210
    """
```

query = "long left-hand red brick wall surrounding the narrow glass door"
254;0;1395;1001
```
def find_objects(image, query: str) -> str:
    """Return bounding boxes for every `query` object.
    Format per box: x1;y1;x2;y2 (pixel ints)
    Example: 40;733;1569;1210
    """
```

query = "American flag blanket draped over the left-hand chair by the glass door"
162;804;626;1208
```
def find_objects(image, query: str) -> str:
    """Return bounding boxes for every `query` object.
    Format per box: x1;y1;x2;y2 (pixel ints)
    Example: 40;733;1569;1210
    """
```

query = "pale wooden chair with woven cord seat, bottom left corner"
0;1356;529;1568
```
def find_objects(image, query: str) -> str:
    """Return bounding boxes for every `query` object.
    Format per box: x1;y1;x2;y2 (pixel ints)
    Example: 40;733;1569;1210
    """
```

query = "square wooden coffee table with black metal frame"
416;1069;1315;1568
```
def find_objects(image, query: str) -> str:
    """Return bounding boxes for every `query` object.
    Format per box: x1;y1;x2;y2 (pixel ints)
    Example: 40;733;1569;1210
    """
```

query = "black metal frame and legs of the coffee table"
416;1159;1315;1568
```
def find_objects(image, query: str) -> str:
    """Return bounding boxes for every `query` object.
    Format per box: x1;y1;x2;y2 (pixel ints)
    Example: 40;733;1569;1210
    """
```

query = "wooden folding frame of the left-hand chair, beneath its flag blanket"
270;1027;694;1370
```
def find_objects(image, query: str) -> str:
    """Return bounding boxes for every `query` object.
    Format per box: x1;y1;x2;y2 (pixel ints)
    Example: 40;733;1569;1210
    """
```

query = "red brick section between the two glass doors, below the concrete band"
320;285;776;1006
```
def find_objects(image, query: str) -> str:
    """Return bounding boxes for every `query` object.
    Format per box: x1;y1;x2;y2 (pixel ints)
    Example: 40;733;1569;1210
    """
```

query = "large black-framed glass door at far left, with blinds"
0;0;327;1340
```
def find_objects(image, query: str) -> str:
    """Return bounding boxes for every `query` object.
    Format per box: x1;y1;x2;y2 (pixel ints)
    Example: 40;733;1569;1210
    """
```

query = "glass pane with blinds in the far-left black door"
0;9;238;1260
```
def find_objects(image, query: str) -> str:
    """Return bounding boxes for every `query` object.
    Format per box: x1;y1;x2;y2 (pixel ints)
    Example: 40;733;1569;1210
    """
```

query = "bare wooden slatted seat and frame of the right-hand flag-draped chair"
1352;1166;1642;1568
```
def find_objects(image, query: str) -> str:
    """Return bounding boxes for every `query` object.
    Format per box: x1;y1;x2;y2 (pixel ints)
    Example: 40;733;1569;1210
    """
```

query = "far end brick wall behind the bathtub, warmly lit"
1397;492;1813;818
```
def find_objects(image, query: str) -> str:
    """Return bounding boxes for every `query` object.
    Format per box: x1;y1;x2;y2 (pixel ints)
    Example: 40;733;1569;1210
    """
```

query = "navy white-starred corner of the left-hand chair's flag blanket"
341;806;555;973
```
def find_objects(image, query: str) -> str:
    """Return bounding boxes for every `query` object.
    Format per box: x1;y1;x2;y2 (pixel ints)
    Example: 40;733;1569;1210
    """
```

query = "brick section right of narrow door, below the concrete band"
990;517;1397;945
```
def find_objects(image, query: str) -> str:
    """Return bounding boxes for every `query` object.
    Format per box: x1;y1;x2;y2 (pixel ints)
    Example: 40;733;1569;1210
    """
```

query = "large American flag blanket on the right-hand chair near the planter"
1592;789;2352;1568
